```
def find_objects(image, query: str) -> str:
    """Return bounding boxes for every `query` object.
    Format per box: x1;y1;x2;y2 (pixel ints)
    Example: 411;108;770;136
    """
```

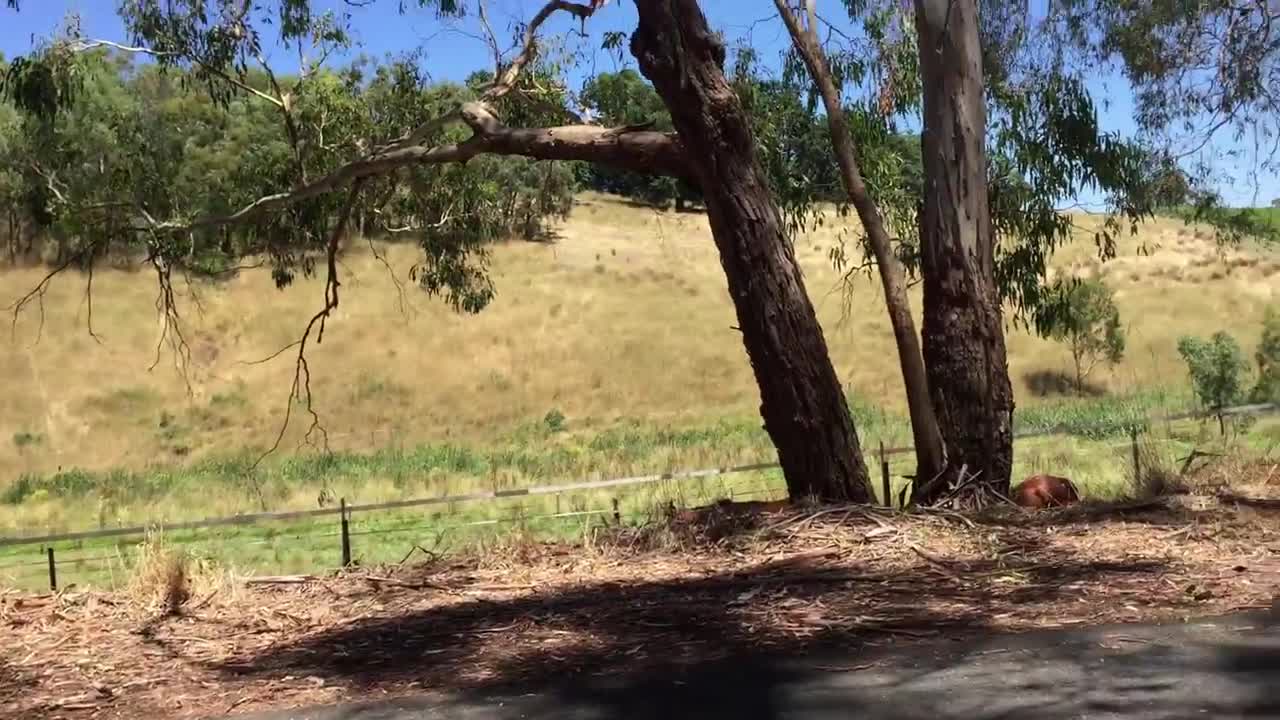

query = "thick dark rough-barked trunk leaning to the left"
631;0;872;502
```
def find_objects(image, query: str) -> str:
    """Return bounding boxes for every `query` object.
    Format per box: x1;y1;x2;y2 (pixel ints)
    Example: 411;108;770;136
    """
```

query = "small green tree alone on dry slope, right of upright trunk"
1048;279;1125;392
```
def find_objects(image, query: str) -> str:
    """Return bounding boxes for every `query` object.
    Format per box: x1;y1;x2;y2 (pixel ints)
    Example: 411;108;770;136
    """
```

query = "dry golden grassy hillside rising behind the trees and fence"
0;190;1280;527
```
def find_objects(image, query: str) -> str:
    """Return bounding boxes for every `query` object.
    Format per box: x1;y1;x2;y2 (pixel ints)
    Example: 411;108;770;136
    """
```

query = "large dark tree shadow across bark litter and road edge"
207;538;1239;719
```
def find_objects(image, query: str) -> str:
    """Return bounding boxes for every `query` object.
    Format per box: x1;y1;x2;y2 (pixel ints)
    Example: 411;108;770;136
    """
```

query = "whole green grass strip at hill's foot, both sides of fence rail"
0;389;1280;588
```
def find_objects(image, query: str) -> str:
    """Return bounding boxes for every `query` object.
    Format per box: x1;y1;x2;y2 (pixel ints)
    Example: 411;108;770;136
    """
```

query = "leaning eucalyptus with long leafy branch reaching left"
6;0;869;501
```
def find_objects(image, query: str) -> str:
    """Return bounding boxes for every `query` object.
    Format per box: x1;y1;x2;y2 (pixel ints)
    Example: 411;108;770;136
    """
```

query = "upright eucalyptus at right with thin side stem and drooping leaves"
774;0;1280;501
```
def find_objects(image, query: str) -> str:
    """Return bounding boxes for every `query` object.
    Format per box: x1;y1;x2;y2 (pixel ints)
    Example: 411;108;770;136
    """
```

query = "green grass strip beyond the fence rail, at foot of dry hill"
0;391;1218;532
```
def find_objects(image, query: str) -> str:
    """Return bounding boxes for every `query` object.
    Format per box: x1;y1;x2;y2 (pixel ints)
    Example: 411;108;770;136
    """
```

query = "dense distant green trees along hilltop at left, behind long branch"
0;49;577;294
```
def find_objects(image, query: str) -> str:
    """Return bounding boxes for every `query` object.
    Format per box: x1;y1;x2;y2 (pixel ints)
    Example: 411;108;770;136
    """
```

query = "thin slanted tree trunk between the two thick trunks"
774;0;946;484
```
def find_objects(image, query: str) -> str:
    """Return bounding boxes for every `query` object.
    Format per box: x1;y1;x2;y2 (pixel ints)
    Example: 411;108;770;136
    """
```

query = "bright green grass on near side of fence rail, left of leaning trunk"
0;471;786;591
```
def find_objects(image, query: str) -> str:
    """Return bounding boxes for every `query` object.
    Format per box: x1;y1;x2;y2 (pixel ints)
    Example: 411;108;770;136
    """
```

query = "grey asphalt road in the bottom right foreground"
227;614;1280;720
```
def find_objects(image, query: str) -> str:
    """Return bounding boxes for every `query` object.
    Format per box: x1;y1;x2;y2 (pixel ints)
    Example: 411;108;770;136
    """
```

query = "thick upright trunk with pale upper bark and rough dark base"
915;0;1014;502
